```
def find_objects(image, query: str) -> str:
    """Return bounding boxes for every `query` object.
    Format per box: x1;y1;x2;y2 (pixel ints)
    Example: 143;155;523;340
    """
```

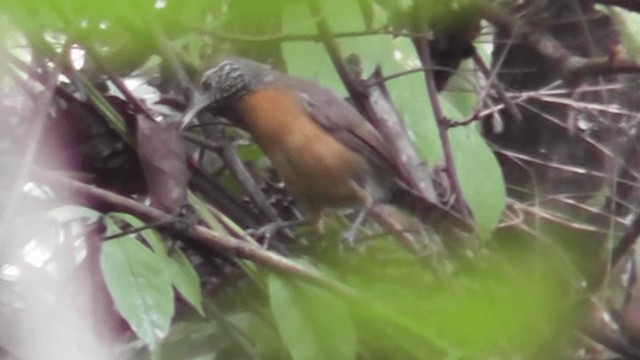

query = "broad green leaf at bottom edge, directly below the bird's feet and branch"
269;275;356;360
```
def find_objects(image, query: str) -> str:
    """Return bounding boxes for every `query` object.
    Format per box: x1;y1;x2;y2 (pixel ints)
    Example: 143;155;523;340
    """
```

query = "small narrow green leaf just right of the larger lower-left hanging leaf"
170;249;204;316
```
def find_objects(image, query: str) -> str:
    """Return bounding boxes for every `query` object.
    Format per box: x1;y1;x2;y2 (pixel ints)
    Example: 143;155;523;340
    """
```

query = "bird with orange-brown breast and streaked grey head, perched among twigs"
182;58;468;236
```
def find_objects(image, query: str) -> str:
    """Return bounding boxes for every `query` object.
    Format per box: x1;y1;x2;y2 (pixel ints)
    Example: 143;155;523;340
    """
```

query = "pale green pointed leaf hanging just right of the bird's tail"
449;126;506;239
